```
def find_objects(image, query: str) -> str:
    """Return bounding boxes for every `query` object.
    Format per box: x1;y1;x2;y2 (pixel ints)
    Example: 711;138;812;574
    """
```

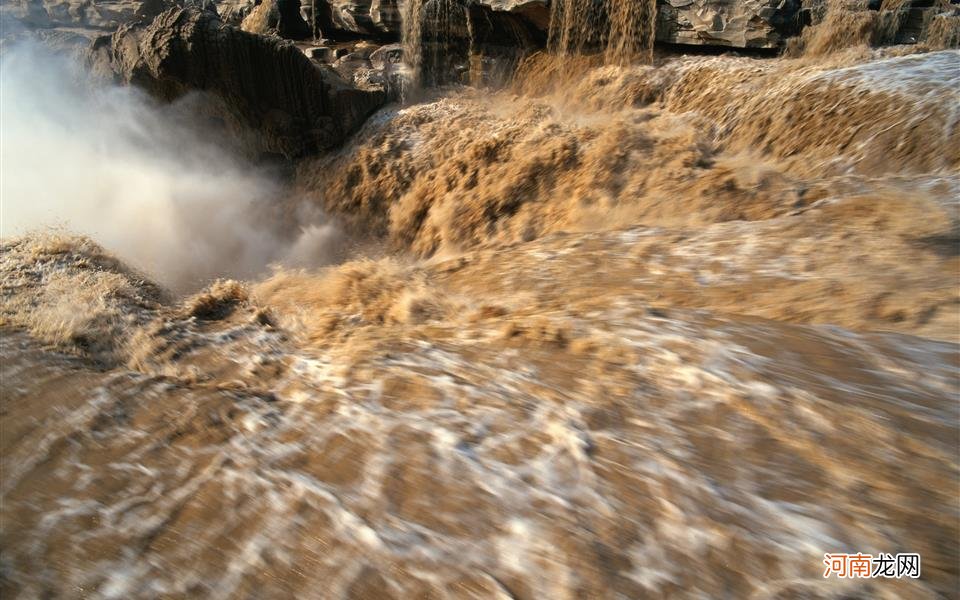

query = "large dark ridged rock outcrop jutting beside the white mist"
92;8;385;158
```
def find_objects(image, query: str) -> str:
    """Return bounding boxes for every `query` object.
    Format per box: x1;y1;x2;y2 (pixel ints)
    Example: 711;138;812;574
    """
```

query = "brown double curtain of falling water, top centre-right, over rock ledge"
548;0;657;65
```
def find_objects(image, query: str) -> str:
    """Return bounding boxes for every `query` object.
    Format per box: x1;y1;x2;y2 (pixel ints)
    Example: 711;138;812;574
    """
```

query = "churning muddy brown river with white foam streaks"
0;16;960;600
